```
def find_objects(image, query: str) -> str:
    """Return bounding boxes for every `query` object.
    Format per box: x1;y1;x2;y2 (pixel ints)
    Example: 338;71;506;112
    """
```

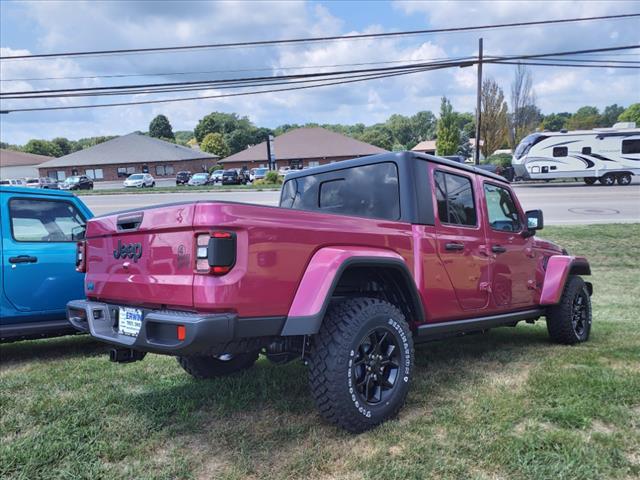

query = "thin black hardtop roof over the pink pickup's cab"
285;151;509;183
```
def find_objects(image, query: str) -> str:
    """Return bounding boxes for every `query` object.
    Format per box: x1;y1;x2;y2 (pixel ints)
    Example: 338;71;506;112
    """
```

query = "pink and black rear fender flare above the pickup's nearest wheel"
281;247;424;336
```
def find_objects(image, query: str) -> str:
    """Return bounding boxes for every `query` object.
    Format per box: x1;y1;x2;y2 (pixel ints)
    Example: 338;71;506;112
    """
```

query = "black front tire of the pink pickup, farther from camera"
547;275;592;345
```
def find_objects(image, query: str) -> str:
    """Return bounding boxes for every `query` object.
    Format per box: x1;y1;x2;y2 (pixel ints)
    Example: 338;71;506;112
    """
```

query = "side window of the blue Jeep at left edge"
9;198;86;242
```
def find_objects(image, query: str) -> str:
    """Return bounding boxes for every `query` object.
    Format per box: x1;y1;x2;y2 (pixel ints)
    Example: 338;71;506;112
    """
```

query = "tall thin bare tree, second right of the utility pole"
509;64;540;148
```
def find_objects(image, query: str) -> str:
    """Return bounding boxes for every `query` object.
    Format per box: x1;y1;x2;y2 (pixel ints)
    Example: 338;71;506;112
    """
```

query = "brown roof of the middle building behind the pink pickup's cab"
221;127;387;163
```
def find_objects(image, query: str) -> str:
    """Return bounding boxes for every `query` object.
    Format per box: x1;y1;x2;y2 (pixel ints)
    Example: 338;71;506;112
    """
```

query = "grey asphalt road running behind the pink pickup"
81;183;640;225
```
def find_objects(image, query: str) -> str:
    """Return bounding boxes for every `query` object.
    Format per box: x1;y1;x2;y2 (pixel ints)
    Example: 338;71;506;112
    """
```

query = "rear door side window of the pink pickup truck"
434;170;478;227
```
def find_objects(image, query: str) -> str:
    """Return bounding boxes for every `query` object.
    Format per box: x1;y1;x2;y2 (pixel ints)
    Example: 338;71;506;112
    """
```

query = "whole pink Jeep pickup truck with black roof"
67;152;592;432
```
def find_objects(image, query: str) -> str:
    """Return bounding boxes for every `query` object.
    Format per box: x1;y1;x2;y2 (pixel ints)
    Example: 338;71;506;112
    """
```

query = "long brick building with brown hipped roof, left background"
38;133;219;181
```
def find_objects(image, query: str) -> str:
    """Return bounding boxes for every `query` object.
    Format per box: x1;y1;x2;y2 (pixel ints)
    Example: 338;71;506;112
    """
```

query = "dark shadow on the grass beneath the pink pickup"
125;326;551;432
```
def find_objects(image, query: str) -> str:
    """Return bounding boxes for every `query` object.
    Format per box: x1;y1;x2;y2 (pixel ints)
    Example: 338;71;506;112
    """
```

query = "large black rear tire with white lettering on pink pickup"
309;298;414;433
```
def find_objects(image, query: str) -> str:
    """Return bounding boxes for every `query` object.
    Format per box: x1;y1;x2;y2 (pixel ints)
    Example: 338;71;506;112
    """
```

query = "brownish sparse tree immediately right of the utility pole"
480;78;509;157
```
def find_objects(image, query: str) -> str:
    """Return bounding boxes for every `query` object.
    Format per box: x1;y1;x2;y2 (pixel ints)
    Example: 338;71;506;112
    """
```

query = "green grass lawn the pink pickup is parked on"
0;224;640;480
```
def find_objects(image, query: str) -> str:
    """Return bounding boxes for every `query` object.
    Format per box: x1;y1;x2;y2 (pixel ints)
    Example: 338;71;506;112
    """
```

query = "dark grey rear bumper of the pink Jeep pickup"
67;300;284;355
